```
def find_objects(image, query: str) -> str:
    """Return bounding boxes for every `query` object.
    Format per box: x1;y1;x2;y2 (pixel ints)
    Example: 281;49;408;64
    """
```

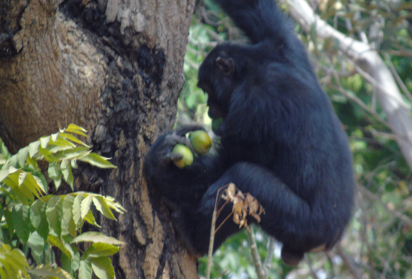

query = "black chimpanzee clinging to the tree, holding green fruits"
144;0;355;265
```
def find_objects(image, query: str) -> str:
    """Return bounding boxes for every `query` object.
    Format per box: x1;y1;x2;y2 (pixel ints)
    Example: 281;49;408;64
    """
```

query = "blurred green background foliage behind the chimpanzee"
177;0;412;278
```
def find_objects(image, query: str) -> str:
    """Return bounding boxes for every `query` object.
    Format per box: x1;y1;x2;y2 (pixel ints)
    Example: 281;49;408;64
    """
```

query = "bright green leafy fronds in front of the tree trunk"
0;124;125;279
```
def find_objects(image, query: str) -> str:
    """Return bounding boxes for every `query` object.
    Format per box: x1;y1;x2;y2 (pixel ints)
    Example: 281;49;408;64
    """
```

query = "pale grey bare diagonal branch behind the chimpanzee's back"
279;0;412;170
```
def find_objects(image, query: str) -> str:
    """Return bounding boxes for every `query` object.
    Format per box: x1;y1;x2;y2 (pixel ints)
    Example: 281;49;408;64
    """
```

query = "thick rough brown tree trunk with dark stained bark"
0;0;197;278
